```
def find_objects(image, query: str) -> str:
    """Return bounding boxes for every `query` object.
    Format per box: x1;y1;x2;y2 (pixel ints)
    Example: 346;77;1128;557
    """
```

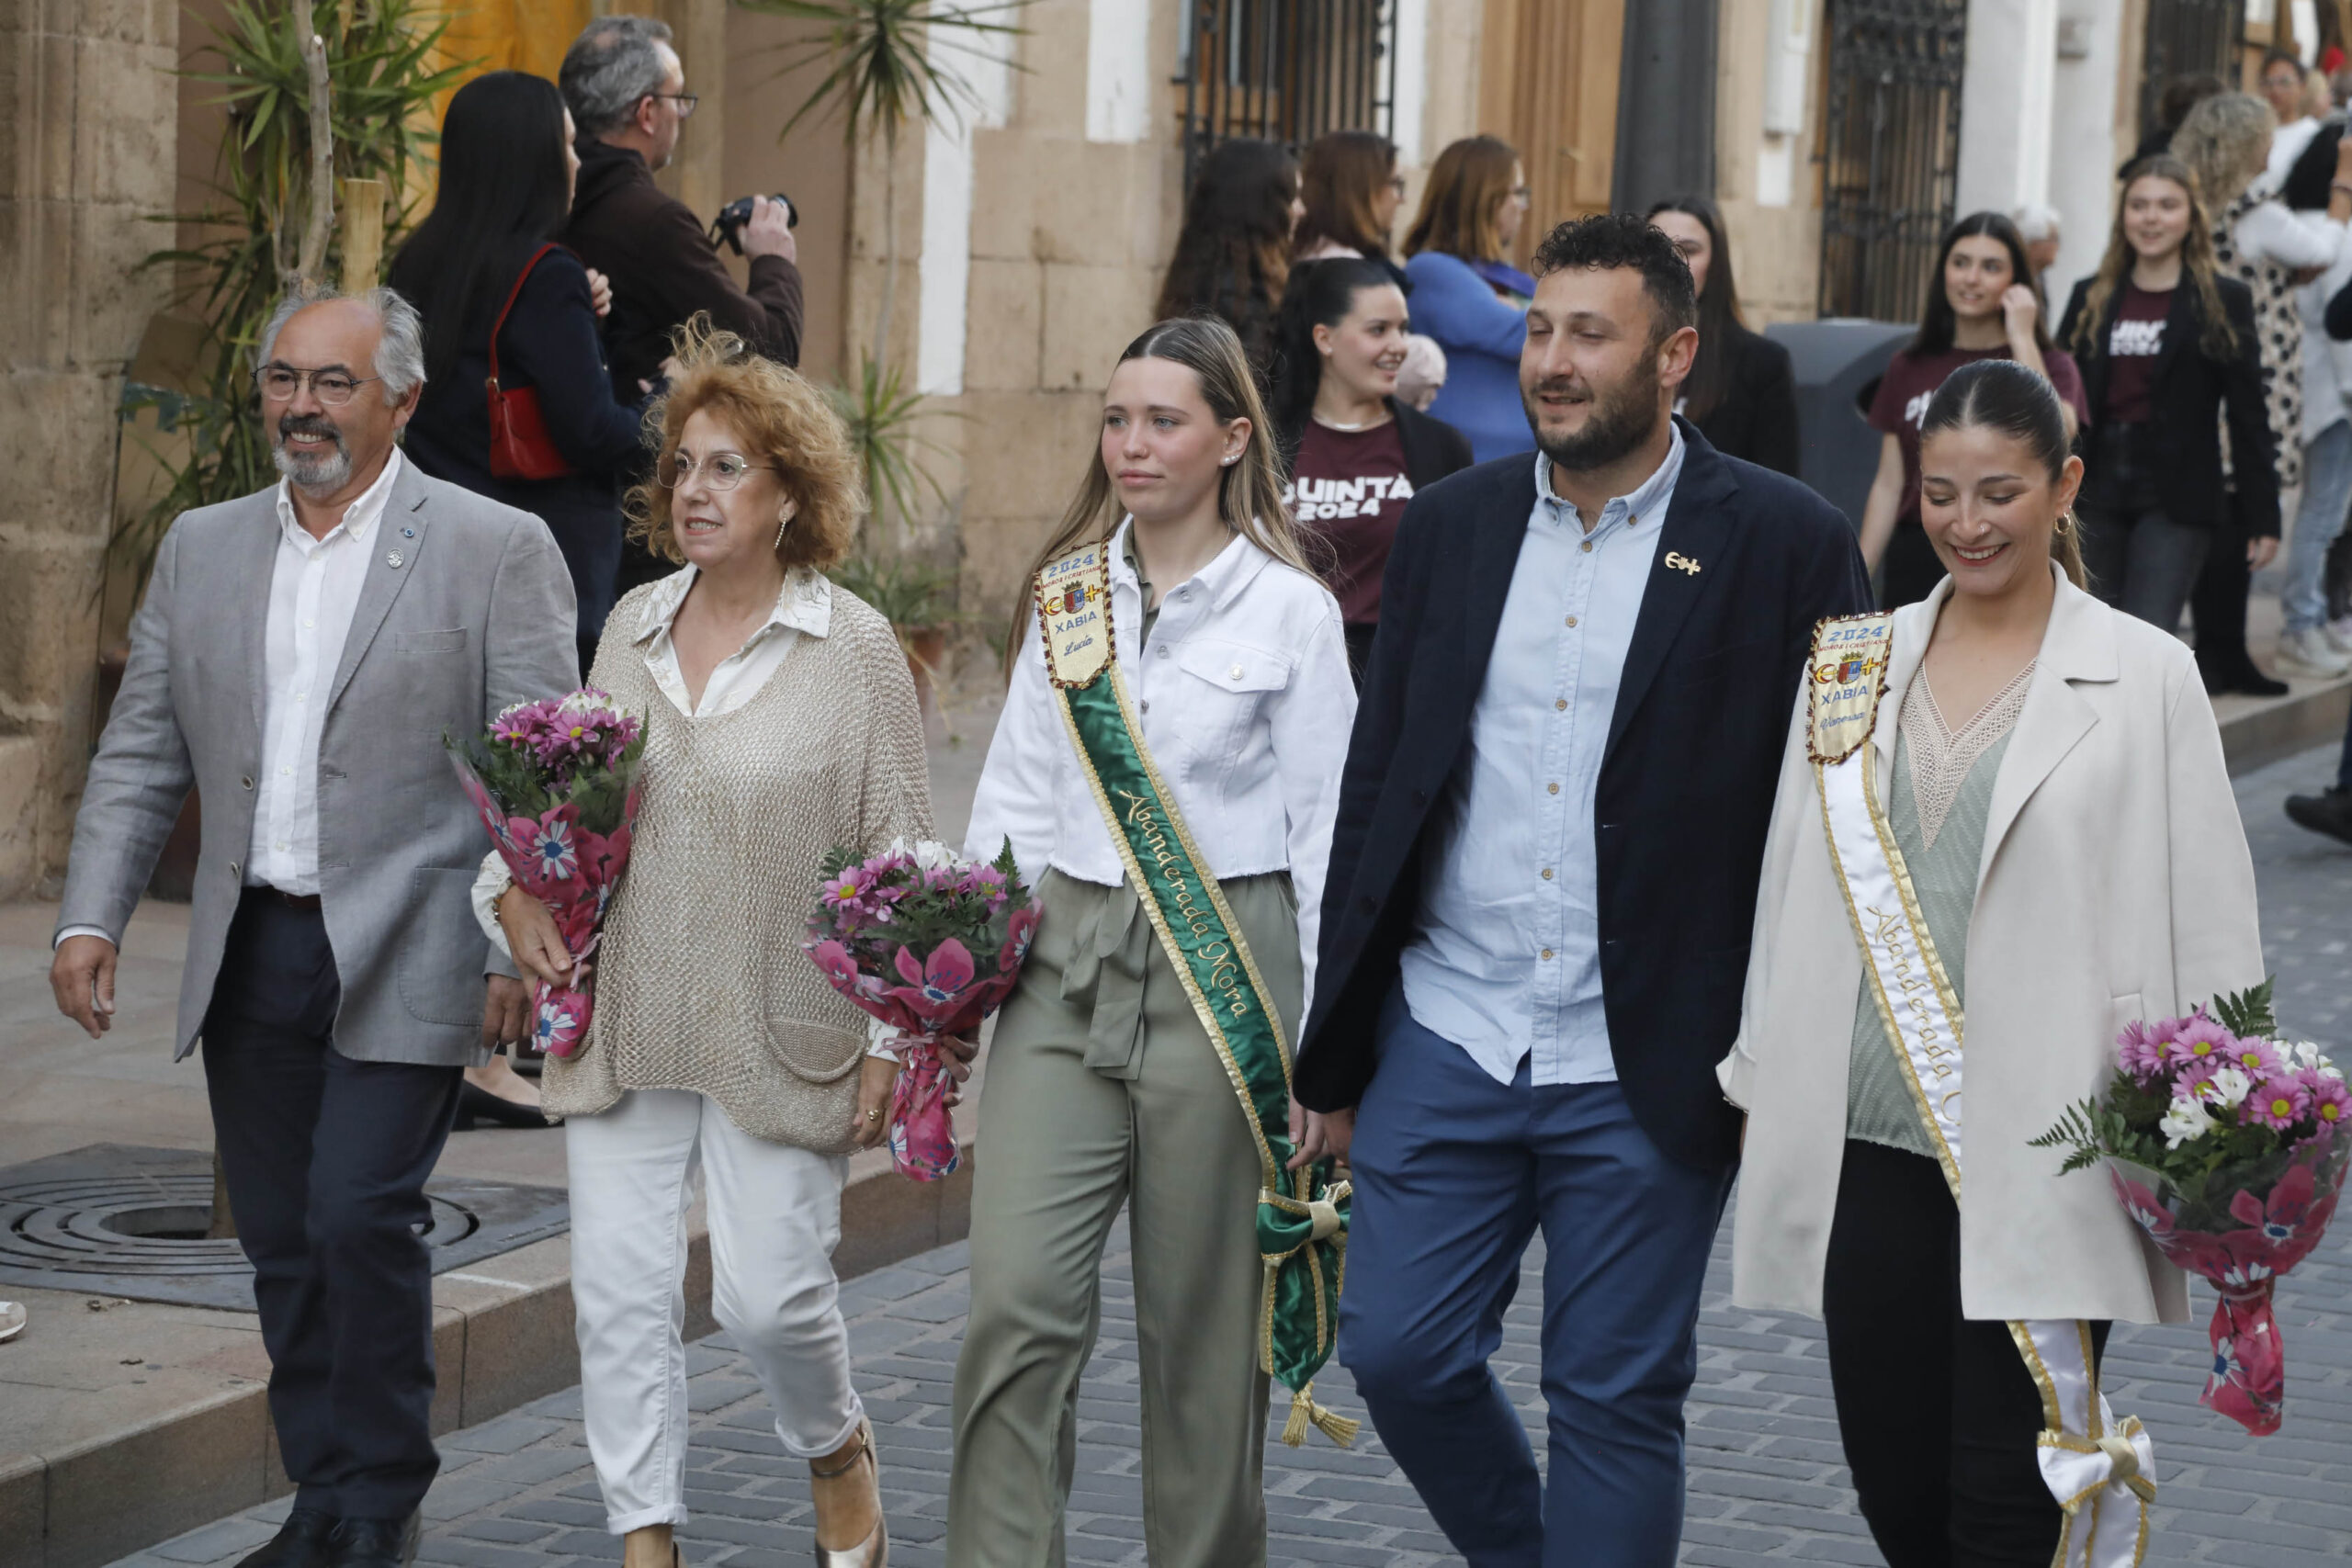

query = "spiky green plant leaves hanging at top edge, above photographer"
736;0;1028;146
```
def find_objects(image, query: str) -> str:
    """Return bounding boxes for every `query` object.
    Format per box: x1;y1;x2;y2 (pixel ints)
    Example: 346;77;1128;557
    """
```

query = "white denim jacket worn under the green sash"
965;522;1355;997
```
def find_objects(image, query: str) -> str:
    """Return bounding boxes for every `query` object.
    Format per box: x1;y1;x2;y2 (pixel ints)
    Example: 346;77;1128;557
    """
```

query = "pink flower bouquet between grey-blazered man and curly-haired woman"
442;686;644;1055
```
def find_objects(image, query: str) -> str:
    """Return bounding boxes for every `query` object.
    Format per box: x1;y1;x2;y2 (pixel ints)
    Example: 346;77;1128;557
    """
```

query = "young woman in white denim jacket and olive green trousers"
948;317;1355;1568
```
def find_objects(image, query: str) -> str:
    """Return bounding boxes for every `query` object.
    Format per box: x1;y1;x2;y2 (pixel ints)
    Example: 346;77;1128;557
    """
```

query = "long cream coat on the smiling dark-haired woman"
1722;564;2263;1324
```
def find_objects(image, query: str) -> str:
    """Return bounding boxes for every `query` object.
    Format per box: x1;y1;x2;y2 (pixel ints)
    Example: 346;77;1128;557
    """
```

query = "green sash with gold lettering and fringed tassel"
1035;541;1357;1446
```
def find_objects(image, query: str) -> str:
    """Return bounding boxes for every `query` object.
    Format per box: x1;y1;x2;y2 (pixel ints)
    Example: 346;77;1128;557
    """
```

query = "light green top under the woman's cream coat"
1847;665;2034;1159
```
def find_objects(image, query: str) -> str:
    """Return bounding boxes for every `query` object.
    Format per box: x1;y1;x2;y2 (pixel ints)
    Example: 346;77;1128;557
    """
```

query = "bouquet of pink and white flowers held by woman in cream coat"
2032;983;2352;1437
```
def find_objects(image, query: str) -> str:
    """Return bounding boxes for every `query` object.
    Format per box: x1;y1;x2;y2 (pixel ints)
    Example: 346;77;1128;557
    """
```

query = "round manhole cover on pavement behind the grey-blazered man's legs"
0;1143;571;1312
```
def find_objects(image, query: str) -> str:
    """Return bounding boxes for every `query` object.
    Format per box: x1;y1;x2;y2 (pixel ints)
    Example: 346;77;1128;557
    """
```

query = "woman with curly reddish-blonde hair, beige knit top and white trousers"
475;317;932;1568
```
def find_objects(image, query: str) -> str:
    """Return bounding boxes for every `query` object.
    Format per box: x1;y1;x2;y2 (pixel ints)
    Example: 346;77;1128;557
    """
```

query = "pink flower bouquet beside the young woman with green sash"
802;840;1037;1182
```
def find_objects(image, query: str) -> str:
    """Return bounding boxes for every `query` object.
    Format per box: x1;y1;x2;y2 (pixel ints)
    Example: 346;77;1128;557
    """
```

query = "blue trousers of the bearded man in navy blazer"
1339;995;1731;1568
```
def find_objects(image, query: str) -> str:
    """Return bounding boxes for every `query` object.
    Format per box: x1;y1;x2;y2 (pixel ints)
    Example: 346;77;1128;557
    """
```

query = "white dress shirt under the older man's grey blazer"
244;446;402;894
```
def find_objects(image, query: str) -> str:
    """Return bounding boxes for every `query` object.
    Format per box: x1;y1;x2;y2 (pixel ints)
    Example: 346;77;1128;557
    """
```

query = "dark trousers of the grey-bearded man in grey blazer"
205;888;458;1518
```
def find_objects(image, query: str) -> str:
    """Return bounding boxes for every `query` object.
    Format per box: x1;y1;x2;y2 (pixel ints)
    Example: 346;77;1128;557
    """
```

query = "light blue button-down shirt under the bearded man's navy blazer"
1402;430;1681;1084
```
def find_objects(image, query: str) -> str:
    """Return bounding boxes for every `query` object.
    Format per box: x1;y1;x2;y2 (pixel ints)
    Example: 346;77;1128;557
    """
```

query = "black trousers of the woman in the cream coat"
1820;1140;2108;1568
